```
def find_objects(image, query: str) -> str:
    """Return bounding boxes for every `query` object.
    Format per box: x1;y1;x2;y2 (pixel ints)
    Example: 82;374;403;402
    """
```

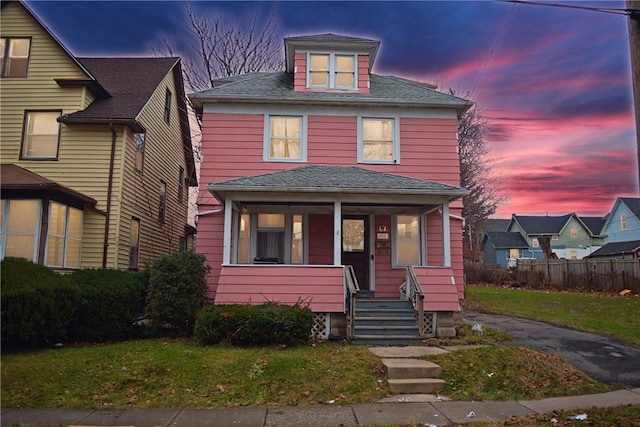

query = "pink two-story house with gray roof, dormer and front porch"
190;34;470;343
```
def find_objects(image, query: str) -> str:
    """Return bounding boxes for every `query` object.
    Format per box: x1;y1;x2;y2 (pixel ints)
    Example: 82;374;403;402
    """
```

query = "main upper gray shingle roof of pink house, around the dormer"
189;71;472;112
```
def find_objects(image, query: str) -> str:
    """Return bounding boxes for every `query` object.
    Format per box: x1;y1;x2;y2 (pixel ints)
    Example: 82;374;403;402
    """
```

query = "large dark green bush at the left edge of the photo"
0;258;80;347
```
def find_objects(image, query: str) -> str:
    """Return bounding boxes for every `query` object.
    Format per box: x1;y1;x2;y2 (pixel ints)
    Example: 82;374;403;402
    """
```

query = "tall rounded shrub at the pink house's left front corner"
146;252;209;336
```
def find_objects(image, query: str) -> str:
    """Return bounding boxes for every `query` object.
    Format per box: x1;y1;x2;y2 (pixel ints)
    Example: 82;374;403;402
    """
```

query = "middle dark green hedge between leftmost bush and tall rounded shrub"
69;269;144;342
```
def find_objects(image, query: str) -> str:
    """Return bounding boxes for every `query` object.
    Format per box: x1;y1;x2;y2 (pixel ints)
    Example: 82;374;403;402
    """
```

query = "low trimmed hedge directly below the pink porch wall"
195;302;313;346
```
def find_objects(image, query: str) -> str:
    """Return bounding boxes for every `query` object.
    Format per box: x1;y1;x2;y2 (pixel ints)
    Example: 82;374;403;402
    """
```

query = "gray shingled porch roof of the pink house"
207;165;468;201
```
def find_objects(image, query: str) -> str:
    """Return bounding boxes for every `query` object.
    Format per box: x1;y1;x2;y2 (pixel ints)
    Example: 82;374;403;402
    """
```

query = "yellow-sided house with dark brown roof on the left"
0;1;197;270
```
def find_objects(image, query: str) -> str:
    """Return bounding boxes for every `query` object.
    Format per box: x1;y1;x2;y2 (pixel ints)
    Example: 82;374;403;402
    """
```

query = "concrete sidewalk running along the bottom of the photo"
0;388;640;427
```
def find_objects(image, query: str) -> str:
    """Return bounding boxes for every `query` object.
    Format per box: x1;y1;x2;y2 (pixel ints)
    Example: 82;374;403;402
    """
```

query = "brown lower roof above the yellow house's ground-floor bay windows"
0;164;97;205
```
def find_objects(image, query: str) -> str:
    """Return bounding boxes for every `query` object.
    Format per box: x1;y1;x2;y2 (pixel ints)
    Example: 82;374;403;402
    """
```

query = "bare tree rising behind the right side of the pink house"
456;89;505;258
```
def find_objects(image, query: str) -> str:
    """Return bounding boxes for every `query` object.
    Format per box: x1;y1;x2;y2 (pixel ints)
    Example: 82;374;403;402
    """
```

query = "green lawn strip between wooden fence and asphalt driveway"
465;285;640;344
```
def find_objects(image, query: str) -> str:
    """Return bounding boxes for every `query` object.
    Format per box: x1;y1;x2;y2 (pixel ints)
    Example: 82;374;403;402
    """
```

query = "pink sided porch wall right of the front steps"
413;267;461;311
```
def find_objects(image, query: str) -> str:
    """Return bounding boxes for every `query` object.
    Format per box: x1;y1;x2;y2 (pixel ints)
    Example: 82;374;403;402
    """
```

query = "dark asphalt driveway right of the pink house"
464;311;640;387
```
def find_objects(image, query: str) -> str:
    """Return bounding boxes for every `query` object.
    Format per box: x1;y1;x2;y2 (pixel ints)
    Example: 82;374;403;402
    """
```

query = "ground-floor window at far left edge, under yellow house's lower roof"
2;199;41;262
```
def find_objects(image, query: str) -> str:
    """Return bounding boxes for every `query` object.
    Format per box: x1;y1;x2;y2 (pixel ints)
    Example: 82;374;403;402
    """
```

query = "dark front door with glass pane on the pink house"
342;216;369;290
